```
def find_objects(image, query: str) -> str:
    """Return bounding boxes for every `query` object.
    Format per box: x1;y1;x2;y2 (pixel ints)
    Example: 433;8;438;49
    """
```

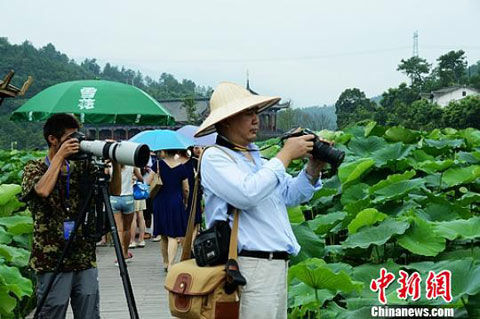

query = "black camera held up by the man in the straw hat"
280;128;345;171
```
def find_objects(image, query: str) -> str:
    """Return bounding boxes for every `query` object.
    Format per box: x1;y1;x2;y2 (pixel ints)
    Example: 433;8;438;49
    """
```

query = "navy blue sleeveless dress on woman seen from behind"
152;160;188;237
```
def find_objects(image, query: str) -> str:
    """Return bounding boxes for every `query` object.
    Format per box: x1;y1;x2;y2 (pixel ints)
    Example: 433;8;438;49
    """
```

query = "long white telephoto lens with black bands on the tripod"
64;132;150;167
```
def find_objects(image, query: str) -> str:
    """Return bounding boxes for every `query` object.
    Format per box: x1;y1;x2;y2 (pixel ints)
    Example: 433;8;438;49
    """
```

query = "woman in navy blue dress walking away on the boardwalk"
148;150;189;269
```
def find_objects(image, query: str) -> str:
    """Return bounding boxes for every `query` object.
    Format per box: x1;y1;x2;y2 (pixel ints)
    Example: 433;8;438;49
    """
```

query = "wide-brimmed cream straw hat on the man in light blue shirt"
195;82;280;137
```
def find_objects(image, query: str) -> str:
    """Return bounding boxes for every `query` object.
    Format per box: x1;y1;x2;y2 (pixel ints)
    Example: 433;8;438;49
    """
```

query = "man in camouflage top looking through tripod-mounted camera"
22;114;121;318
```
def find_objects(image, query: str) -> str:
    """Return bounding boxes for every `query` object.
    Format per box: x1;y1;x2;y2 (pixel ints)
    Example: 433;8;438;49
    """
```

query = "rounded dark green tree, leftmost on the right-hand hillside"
335;88;375;128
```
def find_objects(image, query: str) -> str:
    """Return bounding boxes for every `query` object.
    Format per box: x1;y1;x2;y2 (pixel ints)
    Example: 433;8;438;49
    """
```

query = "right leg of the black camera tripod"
101;185;139;319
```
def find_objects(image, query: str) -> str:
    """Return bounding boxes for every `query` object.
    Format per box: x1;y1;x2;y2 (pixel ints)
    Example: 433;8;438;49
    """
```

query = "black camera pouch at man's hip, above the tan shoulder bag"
193;221;231;267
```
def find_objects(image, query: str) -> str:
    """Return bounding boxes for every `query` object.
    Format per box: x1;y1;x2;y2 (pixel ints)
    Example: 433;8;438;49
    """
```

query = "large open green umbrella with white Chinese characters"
10;80;175;126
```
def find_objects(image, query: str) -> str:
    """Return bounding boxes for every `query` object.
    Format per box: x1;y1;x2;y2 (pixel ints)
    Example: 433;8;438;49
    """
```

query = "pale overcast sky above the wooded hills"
0;0;480;107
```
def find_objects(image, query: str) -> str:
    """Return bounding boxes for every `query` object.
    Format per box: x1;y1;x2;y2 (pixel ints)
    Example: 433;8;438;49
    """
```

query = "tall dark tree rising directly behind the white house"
437;50;467;87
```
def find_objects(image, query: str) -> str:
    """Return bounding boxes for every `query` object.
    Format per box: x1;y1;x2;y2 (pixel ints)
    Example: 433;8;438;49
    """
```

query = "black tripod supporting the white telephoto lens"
34;158;139;319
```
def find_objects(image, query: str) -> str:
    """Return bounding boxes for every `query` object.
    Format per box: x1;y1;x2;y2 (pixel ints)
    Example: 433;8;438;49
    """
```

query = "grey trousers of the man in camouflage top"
37;268;100;319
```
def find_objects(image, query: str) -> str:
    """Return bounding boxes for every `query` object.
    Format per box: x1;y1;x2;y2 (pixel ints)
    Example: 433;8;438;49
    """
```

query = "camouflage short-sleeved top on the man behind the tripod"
22;160;96;273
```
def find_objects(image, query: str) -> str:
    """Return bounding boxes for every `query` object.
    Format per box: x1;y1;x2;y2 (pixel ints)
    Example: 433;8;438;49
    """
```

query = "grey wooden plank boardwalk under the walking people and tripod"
28;240;174;319
